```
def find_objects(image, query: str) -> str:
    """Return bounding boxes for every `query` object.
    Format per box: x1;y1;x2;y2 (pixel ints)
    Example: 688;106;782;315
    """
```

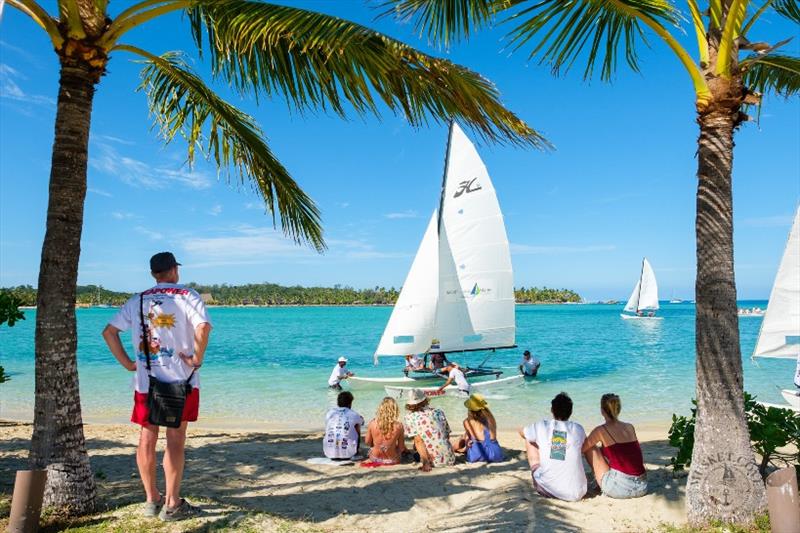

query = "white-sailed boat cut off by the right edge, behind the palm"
753;206;800;412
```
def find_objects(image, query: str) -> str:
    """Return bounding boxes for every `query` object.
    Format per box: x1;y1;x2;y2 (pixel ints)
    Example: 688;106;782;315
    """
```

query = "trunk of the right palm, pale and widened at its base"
686;104;765;525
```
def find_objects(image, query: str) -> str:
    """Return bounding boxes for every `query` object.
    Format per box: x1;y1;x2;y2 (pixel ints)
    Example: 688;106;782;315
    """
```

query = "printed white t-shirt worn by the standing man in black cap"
109;283;211;392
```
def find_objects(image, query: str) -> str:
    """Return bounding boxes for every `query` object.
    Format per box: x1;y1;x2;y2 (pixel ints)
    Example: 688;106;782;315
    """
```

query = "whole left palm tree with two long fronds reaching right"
6;0;546;513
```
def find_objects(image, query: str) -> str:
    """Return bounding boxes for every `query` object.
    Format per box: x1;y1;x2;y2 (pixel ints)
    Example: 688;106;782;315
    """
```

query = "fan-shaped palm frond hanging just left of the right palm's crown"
508;0;680;80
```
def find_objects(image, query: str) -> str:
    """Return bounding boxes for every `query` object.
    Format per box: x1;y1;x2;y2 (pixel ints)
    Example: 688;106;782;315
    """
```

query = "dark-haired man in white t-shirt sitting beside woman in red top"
519;392;586;501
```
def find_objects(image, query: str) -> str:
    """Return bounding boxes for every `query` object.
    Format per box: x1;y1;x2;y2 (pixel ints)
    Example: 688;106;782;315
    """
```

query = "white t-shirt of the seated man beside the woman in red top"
524;420;586;501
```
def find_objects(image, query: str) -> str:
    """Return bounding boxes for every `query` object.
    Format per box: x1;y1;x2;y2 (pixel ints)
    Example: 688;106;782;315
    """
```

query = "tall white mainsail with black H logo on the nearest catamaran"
431;123;516;351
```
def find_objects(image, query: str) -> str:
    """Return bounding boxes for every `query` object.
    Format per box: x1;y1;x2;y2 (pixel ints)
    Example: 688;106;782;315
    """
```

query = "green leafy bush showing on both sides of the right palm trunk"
668;392;800;477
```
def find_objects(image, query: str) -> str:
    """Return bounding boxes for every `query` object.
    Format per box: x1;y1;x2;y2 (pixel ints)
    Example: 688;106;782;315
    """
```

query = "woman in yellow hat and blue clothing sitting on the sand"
455;394;505;463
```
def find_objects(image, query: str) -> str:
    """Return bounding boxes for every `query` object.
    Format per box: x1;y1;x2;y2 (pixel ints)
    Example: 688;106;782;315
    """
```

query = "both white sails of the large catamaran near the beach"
354;122;522;394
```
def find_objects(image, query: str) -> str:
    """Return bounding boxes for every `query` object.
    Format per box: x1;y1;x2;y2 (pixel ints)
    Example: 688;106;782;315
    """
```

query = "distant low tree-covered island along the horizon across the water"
0;283;582;307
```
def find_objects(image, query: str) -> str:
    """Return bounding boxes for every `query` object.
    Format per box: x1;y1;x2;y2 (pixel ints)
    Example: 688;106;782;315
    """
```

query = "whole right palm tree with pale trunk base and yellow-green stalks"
389;0;800;524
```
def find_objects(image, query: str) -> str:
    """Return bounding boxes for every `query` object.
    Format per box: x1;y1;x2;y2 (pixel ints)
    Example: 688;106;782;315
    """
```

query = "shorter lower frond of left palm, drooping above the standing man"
116;45;325;252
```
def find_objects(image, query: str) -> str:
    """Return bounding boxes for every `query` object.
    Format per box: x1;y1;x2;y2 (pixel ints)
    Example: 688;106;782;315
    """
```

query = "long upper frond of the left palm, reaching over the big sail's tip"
189;0;549;147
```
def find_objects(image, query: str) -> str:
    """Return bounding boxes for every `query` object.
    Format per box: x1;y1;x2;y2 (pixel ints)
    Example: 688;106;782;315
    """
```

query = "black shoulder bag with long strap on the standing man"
139;294;195;428
